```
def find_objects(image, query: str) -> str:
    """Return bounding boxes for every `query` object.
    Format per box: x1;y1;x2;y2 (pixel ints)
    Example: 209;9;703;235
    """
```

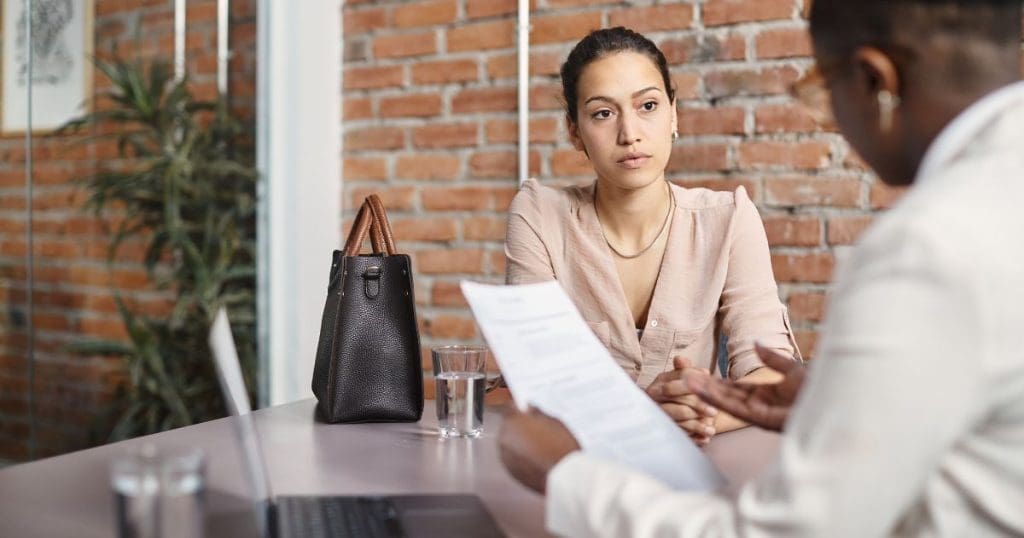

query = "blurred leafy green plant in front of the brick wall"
59;53;257;441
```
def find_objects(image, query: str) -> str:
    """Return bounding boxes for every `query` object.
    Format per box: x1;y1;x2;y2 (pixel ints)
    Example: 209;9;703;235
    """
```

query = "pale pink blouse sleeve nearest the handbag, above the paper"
505;179;555;284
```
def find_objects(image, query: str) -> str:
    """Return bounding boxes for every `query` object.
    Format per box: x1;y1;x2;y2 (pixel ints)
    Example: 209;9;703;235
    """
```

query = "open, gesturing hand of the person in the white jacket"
686;345;807;431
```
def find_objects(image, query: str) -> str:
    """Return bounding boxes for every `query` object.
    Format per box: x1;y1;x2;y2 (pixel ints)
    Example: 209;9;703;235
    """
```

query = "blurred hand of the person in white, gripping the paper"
498;409;580;493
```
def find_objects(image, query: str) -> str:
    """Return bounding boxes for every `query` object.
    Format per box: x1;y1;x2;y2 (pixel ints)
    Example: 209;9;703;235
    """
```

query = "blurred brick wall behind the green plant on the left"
0;0;256;461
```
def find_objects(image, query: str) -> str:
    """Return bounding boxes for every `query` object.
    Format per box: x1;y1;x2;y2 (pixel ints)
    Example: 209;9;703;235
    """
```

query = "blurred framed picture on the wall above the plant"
0;0;93;133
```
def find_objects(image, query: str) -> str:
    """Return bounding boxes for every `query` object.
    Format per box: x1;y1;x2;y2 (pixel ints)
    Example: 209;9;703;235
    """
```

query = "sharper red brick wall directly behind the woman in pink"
343;0;895;389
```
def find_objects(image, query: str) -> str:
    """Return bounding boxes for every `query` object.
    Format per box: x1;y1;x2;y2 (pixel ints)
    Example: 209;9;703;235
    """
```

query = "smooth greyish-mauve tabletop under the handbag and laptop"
0;401;777;537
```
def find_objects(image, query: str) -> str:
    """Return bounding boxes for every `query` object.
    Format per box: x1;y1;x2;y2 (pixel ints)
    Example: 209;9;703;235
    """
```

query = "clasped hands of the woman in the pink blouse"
646;357;718;447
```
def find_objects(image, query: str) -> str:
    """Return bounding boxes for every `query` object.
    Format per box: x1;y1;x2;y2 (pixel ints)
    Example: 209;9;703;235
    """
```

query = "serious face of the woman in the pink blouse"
568;52;676;190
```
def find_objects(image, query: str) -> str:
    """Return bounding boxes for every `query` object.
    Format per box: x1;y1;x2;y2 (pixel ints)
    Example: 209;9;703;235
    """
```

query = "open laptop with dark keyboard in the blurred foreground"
209;308;505;538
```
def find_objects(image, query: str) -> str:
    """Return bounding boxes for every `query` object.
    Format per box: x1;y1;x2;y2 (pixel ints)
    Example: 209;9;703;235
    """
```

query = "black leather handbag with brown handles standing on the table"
312;195;423;422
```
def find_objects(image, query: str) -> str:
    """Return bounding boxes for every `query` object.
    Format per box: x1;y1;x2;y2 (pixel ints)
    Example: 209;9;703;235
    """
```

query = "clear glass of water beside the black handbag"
430;345;487;439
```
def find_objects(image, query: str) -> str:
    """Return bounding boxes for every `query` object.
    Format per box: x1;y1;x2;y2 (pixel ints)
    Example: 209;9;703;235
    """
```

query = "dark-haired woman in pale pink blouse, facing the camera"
505;28;800;444
